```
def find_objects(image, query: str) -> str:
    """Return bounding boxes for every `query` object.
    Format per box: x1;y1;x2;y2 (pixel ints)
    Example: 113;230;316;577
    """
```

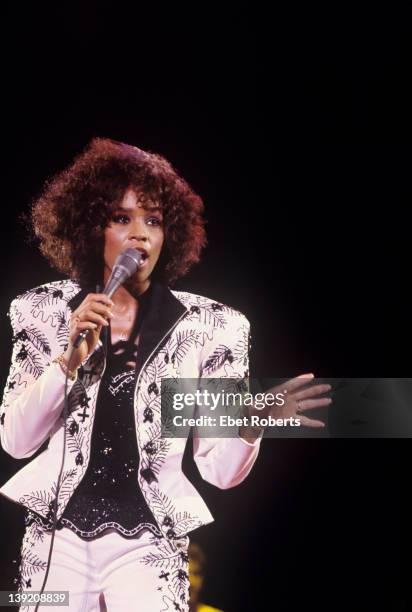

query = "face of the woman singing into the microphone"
104;189;164;293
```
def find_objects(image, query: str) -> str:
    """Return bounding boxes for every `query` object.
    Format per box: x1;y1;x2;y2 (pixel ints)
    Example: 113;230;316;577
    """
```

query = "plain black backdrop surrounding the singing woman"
0;1;412;612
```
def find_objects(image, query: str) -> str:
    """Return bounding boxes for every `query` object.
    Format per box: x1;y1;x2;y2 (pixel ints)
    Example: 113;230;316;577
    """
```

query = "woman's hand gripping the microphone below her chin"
64;293;114;371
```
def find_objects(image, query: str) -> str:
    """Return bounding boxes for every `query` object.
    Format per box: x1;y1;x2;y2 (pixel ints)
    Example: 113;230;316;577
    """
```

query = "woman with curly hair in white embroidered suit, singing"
1;138;261;612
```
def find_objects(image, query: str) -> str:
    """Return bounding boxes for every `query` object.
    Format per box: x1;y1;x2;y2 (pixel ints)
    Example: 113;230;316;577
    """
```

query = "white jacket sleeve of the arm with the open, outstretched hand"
193;313;261;489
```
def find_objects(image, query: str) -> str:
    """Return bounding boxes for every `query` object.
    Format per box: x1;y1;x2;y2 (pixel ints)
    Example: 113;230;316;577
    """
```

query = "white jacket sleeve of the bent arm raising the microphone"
0;298;73;459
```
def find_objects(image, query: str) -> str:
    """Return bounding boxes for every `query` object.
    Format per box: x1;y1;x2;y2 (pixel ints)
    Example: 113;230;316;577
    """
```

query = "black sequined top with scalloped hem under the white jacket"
59;282;162;538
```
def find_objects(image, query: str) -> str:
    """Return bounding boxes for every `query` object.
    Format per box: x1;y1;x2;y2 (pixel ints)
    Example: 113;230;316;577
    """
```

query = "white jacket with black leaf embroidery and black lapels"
0;280;260;539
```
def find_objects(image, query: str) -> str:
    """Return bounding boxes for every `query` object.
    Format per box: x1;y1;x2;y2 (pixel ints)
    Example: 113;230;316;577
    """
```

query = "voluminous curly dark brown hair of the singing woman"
30;138;206;286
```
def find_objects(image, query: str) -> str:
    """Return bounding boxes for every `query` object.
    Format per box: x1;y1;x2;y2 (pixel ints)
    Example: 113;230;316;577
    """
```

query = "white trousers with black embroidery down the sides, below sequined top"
16;522;189;612
